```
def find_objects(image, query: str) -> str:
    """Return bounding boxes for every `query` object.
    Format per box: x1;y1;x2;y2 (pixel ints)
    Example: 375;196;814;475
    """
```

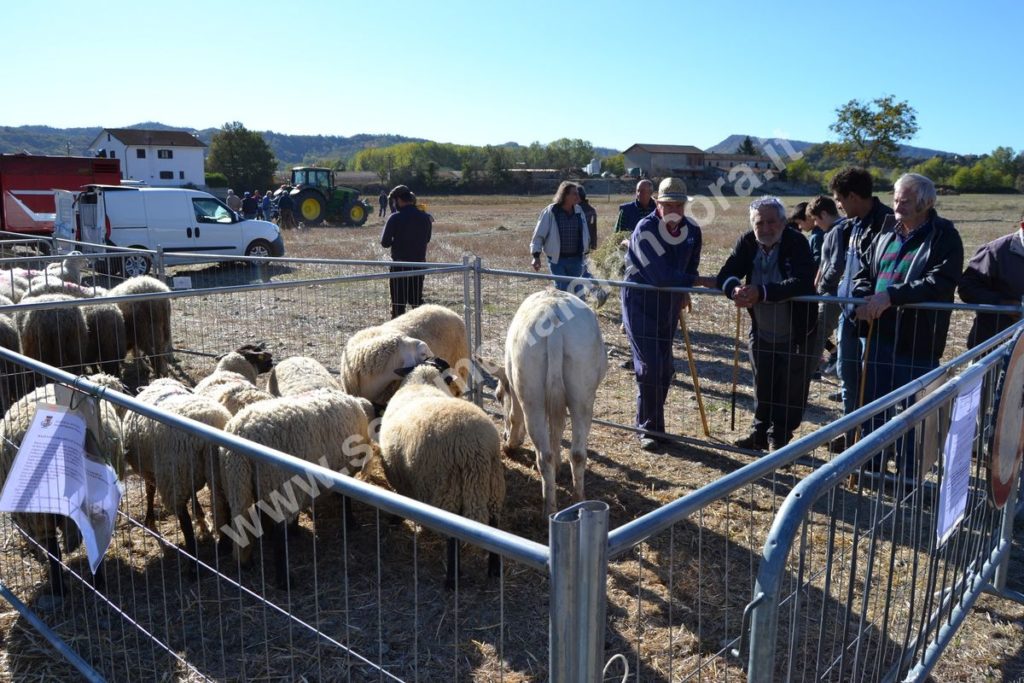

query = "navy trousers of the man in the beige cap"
622;288;682;432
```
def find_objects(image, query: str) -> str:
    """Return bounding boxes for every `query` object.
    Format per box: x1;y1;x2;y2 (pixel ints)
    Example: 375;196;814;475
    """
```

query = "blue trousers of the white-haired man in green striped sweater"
864;336;939;478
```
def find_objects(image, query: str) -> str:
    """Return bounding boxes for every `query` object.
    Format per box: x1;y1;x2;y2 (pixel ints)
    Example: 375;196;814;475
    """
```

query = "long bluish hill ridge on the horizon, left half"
0;121;618;166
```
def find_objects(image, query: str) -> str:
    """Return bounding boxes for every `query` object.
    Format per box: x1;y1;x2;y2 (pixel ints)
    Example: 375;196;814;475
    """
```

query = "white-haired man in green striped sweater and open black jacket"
853;173;964;478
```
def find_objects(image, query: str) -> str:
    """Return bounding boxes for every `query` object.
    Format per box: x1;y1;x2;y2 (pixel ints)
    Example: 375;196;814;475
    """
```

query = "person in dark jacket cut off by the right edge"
959;209;1024;348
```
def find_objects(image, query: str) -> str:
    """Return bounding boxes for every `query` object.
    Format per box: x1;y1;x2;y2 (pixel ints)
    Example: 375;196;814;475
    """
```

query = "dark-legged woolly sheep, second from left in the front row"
124;379;231;572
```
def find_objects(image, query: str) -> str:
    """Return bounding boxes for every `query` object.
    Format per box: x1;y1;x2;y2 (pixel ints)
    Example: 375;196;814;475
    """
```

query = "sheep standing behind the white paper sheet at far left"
0;375;124;594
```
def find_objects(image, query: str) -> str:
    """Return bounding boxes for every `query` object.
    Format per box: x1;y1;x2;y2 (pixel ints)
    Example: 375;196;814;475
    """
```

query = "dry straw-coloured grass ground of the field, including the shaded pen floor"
0;189;1024;683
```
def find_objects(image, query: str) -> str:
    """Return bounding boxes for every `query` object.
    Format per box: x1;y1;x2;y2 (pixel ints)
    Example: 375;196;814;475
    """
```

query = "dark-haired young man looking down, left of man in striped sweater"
828;167;893;453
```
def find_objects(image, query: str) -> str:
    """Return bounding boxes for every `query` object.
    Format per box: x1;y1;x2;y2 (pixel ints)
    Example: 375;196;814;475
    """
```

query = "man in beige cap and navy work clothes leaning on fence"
622;178;715;451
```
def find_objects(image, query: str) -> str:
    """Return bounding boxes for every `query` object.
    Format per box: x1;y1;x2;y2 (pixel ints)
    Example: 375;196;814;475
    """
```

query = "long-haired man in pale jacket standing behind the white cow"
529;180;590;294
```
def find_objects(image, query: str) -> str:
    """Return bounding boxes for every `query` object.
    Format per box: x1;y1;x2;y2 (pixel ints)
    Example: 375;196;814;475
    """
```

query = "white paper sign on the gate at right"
935;377;981;545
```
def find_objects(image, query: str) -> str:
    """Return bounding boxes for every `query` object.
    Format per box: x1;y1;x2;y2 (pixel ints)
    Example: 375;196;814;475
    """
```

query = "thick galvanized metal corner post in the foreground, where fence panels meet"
548;501;608;683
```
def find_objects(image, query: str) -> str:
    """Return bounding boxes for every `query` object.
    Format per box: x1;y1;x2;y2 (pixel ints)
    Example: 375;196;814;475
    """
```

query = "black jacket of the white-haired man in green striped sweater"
852;209;964;365
